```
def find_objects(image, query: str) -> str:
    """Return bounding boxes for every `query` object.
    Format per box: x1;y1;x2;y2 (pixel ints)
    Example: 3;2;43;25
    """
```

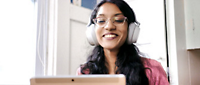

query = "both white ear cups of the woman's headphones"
86;22;140;46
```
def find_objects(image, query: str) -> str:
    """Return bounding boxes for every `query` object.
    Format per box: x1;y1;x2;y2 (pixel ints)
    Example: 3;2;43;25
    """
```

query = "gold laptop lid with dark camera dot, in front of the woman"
30;74;126;85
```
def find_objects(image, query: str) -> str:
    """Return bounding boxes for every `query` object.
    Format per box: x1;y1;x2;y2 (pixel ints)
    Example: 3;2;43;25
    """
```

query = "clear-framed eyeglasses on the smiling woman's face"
93;16;127;27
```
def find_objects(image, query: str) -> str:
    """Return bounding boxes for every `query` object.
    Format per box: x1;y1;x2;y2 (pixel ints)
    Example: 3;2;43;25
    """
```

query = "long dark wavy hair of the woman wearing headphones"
81;0;149;85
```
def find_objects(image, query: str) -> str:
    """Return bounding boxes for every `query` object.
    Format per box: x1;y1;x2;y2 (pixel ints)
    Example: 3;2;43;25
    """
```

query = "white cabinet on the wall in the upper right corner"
184;0;200;50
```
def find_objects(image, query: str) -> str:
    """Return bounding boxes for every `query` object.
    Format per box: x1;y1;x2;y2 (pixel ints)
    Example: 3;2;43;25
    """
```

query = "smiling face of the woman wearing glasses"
95;3;128;50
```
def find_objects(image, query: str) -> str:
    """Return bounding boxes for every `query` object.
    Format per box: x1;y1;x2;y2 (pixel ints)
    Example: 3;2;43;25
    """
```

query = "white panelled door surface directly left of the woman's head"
69;5;94;75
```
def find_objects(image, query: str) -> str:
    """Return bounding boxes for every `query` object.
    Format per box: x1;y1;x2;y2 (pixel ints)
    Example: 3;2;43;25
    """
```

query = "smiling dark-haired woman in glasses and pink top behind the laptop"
77;0;169;85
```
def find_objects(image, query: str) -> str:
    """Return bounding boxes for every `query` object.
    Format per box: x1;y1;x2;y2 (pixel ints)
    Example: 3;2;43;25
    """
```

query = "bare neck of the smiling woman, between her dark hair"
104;49;119;74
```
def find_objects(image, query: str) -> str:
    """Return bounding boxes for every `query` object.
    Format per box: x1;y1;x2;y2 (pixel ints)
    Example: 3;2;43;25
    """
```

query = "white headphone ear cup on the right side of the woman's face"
127;22;140;44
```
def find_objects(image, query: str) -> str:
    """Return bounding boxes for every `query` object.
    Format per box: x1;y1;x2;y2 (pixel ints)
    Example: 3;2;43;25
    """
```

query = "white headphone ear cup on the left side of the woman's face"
86;24;99;46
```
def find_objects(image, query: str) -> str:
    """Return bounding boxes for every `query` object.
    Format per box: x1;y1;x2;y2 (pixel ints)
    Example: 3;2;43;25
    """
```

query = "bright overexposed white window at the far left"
0;0;37;85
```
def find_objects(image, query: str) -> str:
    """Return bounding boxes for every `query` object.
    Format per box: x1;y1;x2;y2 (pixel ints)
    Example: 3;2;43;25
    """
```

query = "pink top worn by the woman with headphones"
76;58;169;85
